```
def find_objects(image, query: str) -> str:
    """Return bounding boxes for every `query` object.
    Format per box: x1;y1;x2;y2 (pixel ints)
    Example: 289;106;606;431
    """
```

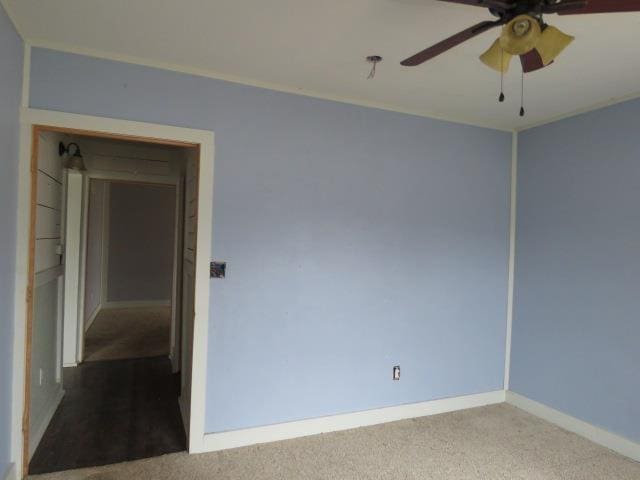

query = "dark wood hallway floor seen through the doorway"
29;357;186;474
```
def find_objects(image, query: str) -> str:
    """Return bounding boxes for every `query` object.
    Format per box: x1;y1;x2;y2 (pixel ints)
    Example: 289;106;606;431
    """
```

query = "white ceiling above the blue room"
2;0;640;129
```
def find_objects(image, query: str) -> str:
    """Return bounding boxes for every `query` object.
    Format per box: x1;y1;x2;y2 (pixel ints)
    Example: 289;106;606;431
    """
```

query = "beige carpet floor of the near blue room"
31;404;640;480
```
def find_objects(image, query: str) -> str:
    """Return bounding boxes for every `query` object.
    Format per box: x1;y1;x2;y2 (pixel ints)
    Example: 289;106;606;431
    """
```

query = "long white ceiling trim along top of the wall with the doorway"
28;38;513;132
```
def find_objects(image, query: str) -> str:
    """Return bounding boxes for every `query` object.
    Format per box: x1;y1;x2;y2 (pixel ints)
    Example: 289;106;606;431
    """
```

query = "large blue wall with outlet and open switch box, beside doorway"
31;49;511;432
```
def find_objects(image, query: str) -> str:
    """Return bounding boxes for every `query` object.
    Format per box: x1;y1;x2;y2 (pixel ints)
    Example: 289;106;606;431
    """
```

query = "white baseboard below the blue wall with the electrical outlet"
200;390;505;453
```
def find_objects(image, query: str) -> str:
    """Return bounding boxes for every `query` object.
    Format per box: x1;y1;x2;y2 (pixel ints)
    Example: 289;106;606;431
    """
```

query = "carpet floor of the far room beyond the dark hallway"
84;307;171;362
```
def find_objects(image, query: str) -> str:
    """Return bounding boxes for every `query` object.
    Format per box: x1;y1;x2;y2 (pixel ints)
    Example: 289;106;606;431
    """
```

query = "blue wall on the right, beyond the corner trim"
511;100;640;441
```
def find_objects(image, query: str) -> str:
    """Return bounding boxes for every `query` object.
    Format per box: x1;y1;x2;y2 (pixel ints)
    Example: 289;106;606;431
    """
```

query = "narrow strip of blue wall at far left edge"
0;1;23;477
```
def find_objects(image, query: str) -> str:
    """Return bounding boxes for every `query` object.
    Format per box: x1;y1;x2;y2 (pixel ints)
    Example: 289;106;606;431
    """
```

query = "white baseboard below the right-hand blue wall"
506;391;640;462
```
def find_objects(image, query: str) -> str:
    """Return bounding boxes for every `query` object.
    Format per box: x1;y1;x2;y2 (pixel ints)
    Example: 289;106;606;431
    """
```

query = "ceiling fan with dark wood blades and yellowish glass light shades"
401;0;640;73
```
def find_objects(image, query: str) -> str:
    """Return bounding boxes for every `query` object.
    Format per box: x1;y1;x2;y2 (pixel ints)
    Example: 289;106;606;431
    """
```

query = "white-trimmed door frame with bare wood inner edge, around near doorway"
11;108;214;478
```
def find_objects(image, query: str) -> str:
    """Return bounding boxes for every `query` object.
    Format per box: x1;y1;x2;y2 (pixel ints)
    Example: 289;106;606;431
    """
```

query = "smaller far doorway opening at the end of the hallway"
84;177;178;367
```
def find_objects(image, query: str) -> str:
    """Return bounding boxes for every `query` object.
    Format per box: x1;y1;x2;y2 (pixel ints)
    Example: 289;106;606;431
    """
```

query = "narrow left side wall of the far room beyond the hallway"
84;179;108;330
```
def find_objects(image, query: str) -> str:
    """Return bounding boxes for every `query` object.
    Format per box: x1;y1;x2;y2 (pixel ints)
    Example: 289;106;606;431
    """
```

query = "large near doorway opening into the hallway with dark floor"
22;126;200;475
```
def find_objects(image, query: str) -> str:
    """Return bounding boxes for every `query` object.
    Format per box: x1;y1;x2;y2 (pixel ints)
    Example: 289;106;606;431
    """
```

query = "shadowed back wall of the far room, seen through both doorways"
107;182;176;305
